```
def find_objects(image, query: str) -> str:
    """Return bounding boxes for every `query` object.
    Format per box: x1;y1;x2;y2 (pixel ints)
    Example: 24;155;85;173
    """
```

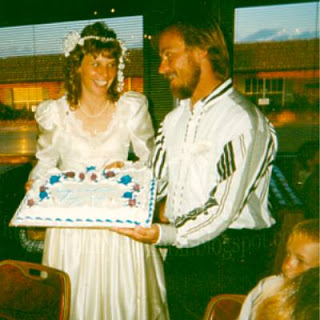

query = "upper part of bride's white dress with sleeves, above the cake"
30;91;154;179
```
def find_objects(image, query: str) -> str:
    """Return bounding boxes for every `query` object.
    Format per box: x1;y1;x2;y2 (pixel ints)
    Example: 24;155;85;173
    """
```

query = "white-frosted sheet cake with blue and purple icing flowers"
11;163;155;227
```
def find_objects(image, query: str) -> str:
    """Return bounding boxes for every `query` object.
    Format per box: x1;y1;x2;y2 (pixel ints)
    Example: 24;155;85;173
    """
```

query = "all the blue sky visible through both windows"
0;2;319;58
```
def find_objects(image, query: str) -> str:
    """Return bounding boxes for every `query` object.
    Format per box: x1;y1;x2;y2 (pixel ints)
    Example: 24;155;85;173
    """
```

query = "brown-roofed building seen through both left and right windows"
0;39;320;112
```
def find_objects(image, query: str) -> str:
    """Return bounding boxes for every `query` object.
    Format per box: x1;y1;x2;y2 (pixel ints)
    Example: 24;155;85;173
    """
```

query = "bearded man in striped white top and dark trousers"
113;17;277;319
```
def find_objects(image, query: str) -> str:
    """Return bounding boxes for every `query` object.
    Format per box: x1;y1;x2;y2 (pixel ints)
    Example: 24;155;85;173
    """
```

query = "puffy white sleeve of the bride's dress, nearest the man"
123;91;154;162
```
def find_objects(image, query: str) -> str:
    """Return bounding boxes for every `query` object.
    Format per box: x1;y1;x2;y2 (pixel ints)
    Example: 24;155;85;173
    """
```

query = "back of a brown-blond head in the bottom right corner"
255;267;320;320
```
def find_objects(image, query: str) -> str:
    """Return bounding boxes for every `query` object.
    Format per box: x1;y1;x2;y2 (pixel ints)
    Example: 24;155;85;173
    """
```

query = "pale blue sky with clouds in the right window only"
235;2;319;42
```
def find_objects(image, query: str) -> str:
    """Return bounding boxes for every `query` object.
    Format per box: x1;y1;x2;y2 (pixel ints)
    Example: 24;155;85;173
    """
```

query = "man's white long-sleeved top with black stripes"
153;79;277;248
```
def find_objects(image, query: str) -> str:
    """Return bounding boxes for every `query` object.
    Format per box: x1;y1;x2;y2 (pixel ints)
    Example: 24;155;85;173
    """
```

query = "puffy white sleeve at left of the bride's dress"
29;100;59;179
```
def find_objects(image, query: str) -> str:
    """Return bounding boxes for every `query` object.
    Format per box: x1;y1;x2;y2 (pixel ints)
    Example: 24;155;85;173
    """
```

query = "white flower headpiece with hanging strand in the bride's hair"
63;31;127;92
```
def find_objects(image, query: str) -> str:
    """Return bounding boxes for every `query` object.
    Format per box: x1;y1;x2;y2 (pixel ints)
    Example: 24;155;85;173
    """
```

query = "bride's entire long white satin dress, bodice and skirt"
30;92;169;320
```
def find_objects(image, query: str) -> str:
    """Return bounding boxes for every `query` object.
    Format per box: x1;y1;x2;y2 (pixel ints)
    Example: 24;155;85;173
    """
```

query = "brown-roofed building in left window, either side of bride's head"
0;49;143;110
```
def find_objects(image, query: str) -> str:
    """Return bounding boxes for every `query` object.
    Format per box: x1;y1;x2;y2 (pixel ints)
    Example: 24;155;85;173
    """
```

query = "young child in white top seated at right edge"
238;219;320;320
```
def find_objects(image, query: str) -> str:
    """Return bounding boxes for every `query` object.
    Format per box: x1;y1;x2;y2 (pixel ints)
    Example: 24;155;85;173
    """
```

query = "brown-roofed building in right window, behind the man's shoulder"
233;39;320;111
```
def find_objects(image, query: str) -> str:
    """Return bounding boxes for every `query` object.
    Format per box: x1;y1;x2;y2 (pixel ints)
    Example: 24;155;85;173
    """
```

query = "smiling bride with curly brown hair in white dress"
28;22;168;320
